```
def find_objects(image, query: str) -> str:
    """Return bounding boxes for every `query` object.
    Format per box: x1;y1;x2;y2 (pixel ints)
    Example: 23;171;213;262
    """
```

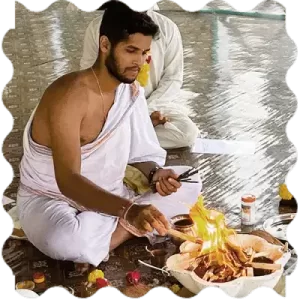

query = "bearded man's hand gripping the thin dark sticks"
152;169;181;196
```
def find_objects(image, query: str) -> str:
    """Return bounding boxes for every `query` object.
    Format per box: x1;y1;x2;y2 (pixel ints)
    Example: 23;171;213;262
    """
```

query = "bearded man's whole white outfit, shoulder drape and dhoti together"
17;85;202;266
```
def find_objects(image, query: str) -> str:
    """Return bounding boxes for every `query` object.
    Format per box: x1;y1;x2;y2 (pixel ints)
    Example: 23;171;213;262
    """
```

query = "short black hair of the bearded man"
98;0;159;46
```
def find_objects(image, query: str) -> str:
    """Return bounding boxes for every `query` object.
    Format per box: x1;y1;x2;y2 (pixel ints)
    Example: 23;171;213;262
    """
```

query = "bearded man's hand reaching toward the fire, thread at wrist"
126;204;169;236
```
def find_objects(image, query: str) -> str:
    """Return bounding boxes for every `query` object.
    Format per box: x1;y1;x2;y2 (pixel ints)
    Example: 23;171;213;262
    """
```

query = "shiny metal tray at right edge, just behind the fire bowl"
263;213;297;241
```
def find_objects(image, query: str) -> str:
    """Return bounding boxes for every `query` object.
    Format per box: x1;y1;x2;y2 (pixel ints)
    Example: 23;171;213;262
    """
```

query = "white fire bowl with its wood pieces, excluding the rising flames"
166;234;290;299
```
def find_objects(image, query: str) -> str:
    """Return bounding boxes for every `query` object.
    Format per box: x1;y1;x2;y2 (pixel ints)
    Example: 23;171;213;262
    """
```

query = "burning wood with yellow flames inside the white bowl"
176;198;283;283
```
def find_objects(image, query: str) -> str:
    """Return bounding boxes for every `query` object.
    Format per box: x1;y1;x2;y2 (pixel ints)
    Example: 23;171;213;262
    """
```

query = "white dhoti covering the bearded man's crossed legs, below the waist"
18;167;201;266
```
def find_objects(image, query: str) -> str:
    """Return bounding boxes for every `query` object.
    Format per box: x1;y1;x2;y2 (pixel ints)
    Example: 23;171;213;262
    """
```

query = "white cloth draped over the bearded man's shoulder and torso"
20;84;166;209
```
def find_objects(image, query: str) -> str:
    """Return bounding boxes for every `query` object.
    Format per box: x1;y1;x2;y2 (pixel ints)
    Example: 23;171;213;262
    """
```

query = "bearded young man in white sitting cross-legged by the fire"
17;1;201;266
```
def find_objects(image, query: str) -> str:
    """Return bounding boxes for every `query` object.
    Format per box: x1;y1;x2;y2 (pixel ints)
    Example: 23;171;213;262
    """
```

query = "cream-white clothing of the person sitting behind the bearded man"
80;9;199;149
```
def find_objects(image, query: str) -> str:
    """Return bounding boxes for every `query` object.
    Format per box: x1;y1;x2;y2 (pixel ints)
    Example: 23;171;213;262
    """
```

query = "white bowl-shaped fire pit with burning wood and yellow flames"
166;197;290;298
